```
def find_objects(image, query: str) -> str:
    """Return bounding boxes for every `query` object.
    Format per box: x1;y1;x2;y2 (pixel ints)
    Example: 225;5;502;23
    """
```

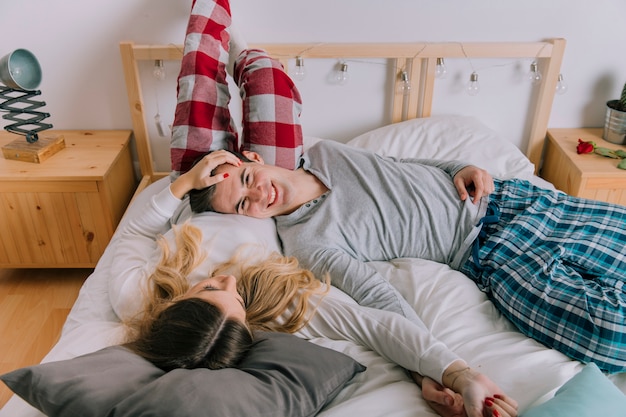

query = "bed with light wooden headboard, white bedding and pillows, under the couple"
0;39;626;417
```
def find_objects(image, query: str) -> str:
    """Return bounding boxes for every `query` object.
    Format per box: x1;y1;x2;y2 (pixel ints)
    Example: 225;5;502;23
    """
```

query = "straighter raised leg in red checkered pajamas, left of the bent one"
170;0;237;175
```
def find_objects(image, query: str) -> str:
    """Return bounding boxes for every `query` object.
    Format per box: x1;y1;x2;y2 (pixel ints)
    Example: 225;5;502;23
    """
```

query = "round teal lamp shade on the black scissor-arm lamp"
0;49;41;90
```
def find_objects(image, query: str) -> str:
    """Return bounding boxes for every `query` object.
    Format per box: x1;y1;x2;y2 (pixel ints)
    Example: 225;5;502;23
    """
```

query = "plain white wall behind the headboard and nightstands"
0;0;626;169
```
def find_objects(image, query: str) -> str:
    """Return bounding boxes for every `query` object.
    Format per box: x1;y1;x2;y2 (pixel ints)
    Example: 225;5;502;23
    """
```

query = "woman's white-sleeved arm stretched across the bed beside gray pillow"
298;288;517;417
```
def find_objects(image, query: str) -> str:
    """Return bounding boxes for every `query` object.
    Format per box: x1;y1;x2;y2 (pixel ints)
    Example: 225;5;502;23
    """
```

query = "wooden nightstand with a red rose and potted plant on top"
541;128;626;205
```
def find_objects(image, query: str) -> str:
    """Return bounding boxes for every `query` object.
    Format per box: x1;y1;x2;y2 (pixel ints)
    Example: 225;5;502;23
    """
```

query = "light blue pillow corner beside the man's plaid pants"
520;363;626;417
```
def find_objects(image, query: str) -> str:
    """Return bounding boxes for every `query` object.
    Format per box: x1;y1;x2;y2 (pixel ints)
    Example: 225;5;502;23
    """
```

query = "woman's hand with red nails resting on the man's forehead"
170;150;241;198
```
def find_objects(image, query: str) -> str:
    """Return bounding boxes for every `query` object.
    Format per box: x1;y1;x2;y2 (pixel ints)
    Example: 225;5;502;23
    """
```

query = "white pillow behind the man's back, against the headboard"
348;116;535;179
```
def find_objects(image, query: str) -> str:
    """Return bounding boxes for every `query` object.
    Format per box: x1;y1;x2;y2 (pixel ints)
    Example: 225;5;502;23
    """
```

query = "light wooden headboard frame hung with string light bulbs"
120;38;566;185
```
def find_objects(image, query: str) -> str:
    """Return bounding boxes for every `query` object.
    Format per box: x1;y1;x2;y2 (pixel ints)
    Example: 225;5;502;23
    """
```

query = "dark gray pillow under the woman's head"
0;332;365;417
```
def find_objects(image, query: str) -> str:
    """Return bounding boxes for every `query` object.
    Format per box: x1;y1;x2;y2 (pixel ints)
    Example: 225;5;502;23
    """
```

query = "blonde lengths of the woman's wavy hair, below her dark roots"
128;223;329;339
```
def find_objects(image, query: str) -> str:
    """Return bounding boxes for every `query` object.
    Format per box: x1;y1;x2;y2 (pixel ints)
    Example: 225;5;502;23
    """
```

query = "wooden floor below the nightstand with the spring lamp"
0;268;93;408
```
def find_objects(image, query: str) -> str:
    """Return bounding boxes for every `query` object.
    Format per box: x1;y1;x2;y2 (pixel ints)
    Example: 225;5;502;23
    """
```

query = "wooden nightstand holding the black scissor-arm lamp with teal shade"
0;130;137;268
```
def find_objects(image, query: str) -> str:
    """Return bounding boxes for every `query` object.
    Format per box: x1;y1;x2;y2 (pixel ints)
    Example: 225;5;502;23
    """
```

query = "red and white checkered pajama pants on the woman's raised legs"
170;0;302;175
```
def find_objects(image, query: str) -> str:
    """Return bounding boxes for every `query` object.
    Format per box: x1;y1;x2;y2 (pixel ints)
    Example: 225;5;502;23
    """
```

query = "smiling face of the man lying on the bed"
212;161;297;219
